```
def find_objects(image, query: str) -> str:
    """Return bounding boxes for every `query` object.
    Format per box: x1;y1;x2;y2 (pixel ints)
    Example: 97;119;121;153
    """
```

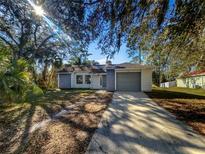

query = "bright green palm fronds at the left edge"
0;59;31;100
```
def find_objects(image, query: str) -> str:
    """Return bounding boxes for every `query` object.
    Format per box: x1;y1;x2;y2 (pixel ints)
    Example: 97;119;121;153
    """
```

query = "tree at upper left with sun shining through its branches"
0;0;88;92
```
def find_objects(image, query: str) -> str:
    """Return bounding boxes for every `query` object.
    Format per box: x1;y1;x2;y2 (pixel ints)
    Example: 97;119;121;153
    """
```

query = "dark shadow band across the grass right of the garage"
146;89;205;99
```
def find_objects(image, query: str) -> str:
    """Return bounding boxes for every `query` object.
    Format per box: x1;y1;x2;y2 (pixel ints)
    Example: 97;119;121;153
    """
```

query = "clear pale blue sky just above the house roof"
88;42;131;64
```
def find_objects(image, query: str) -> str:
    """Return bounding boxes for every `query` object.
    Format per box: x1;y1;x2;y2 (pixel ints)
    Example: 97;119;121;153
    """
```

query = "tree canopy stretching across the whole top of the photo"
0;0;205;60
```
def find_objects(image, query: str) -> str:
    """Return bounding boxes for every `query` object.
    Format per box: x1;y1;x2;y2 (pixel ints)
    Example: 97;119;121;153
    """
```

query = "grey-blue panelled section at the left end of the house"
59;74;71;89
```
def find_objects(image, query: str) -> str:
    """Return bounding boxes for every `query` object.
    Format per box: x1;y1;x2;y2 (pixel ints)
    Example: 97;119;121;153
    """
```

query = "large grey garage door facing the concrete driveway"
116;72;141;91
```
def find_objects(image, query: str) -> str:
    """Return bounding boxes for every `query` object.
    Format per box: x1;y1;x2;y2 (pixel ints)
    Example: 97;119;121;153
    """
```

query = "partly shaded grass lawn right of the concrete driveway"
147;87;205;135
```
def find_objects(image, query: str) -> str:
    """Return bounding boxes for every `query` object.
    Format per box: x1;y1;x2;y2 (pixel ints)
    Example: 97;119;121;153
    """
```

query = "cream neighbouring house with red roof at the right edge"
176;70;205;88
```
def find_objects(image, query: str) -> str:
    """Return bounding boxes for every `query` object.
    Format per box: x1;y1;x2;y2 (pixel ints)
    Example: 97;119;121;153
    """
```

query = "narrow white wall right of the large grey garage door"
141;69;152;91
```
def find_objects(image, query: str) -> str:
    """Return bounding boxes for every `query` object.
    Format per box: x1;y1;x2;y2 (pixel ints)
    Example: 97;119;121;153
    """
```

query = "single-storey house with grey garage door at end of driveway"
58;63;152;91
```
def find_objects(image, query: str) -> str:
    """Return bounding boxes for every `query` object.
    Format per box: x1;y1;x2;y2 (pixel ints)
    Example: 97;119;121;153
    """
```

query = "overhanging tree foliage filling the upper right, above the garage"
88;0;205;83
